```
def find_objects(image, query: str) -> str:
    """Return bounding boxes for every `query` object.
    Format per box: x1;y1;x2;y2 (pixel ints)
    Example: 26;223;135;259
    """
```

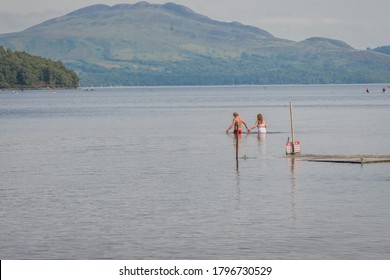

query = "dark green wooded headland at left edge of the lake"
0;46;79;89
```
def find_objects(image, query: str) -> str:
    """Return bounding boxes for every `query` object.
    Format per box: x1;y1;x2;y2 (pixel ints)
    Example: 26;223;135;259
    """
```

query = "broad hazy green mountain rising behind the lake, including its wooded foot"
0;2;390;86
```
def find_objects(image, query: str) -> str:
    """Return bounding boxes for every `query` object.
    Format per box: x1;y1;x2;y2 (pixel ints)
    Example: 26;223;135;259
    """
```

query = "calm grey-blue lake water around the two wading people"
0;85;390;260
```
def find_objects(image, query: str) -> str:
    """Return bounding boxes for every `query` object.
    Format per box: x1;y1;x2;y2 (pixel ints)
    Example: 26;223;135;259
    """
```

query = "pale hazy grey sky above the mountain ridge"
0;0;390;49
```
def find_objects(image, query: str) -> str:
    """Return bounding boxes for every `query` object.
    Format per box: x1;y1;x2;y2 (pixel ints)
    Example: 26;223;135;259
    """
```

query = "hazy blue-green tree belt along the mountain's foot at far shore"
72;53;390;86
